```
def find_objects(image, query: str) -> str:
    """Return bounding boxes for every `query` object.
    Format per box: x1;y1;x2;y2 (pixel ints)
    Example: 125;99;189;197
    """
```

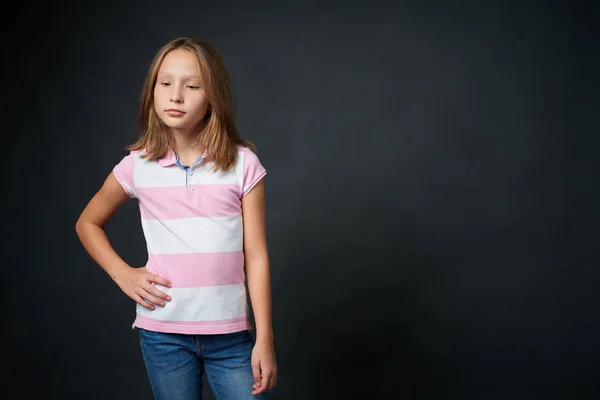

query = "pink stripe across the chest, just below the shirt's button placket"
136;184;242;219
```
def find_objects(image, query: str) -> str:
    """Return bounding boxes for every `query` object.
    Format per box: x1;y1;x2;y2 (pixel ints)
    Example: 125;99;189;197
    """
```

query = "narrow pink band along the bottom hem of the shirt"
131;314;252;335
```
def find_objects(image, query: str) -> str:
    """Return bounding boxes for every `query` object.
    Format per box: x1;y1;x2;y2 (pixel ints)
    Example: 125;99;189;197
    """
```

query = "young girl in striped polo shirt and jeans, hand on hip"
76;37;277;400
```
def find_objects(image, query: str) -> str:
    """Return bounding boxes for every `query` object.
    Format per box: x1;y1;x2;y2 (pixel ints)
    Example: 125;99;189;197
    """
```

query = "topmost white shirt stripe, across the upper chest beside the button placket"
133;152;244;188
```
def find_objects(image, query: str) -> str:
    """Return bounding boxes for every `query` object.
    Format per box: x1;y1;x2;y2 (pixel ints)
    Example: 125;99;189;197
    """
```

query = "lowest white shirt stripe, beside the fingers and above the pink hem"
137;284;247;321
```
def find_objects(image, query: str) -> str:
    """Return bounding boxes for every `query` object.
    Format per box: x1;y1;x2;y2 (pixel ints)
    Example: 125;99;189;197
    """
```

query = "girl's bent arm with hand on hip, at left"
75;172;171;310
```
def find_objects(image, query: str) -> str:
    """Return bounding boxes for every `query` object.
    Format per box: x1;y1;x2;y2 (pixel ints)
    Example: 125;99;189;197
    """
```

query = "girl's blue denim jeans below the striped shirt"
138;328;269;400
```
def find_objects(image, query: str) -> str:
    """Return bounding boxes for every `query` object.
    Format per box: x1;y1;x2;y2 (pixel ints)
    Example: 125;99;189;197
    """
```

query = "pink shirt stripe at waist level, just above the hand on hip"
147;251;246;288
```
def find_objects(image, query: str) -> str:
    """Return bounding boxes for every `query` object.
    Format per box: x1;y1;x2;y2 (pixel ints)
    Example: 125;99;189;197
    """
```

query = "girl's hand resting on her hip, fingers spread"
115;267;171;310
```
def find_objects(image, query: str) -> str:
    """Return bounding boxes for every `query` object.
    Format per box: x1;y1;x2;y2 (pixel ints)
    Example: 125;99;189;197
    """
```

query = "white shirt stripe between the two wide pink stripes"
142;215;244;254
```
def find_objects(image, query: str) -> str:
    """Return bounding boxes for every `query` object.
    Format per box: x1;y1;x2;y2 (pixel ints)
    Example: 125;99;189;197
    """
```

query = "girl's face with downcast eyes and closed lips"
154;49;208;134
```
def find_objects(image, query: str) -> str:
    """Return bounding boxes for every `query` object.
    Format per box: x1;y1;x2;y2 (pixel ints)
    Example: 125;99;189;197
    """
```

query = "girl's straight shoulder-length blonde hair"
126;37;256;171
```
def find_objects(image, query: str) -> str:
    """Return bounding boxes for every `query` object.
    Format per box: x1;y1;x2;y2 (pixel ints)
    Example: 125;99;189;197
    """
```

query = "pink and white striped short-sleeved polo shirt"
113;146;267;334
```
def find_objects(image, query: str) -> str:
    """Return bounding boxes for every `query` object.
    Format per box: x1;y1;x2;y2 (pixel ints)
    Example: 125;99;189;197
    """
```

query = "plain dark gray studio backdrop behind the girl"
2;1;600;400
